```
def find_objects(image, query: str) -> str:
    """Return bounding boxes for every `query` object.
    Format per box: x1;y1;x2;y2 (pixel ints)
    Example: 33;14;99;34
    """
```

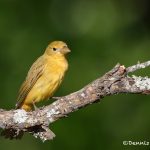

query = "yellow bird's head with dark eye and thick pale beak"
45;41;71;55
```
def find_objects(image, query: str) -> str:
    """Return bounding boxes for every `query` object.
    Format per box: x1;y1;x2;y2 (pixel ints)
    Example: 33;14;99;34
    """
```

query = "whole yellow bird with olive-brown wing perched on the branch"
16;41;70;111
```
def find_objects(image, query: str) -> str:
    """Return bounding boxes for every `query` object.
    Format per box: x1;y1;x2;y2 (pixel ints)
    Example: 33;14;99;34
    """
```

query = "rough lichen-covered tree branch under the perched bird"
0;61;150;141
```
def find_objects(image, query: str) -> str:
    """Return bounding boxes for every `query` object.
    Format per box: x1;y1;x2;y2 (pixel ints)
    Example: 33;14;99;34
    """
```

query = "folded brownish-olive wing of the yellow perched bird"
16;56;45;108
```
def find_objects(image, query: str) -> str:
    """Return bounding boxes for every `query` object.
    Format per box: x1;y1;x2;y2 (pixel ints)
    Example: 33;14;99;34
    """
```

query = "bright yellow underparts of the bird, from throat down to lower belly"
26;56;68;103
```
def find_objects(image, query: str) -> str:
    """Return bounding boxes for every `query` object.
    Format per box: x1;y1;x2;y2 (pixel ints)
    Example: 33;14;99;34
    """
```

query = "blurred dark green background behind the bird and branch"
0;0;150;150
